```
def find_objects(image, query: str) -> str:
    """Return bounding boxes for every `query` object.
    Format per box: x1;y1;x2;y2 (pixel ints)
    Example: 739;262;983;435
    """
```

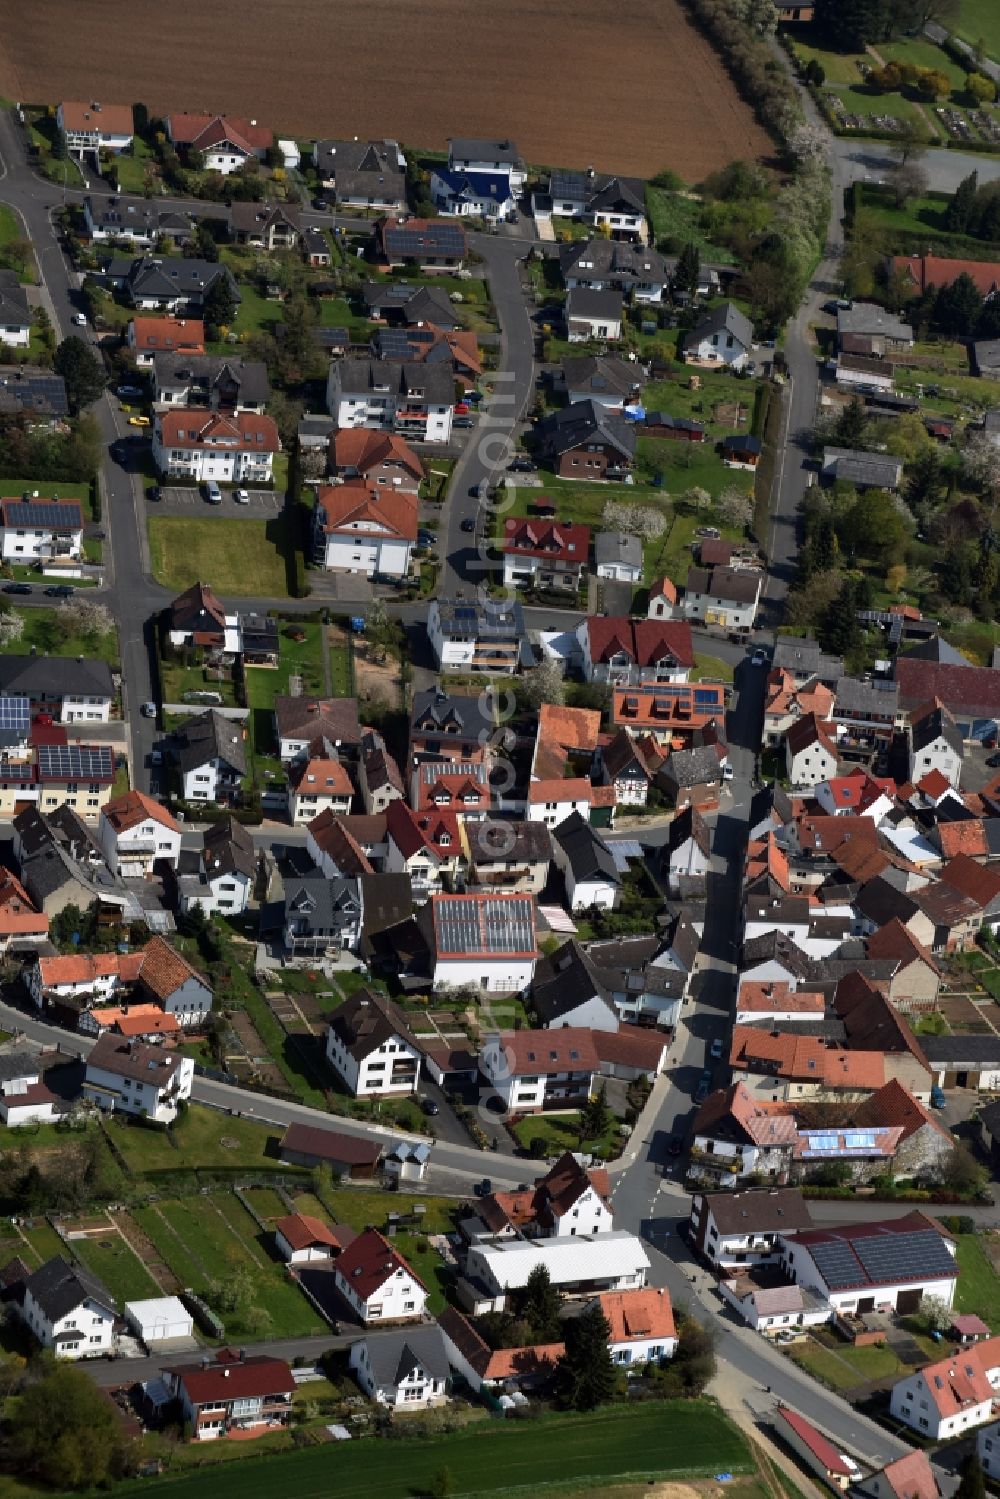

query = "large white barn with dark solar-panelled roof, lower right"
780;1211;958;1315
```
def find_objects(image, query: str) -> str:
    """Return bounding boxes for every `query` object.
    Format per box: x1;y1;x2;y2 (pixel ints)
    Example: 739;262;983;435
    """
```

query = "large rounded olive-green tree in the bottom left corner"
4;1364;124;1490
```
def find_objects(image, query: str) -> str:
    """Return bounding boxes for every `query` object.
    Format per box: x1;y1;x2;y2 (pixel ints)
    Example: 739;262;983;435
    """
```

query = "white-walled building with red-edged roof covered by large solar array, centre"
416;887;538;994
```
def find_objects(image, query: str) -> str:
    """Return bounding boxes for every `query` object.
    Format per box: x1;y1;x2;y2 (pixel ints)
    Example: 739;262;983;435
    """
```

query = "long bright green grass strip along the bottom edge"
117;1400;753;1499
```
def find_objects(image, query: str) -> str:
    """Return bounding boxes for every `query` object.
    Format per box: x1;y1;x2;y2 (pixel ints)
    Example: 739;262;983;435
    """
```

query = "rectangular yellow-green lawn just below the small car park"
148;514;295;598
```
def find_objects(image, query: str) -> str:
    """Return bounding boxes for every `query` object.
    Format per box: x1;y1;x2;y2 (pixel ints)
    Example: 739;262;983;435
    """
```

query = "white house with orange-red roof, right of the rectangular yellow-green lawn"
313;478;417;580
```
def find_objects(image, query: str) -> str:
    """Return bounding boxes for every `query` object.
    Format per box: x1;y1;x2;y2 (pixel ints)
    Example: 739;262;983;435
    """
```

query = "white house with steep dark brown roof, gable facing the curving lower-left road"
327;989;420;1099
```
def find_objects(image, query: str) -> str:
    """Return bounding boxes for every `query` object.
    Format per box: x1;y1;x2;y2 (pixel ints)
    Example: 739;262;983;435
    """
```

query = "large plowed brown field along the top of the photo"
0;0;769;181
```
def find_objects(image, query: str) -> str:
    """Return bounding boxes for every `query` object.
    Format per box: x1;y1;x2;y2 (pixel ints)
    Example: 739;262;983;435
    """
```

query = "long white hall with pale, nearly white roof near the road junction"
459;1229;649;1312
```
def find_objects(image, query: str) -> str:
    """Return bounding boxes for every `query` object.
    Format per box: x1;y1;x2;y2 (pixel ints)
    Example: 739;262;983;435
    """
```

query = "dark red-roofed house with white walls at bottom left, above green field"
162;1348;295;1442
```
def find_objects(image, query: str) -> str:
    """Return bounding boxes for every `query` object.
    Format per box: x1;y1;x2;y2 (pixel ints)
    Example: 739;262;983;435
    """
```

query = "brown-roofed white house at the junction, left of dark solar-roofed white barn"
690;1187;813;1273
